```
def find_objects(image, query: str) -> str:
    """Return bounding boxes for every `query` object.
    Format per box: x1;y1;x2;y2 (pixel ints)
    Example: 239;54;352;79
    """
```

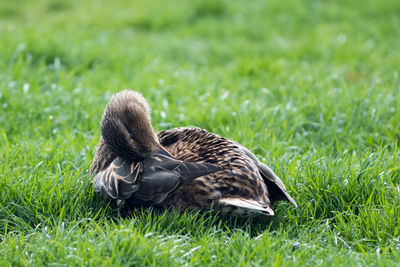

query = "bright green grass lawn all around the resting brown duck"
0;0;400;266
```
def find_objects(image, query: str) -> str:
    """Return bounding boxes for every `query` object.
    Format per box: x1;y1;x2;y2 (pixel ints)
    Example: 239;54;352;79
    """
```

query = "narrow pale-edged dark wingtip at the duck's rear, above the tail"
237;144;297;207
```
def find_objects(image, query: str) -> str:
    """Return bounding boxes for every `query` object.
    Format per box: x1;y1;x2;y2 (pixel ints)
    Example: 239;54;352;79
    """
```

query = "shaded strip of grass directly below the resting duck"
93;200;292;237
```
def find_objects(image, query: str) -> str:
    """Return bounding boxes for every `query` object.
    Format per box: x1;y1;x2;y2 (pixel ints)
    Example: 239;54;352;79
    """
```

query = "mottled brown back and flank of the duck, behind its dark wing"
158;128;286;216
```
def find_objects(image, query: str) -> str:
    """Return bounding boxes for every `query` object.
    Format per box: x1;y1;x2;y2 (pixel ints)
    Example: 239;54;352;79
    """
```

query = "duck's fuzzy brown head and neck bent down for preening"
101;90;168;161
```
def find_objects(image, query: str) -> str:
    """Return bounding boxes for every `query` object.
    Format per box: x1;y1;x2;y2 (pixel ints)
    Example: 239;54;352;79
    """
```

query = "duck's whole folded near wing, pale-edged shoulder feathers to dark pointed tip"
93;154;221;206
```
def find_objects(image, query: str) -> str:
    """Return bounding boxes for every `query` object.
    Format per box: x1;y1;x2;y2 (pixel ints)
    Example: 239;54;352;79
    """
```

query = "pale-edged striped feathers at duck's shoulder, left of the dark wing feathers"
93;157;142;200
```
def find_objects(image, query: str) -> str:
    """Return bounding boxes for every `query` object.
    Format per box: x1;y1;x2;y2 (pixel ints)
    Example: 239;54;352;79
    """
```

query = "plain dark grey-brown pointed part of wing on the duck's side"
132;154;222;204
